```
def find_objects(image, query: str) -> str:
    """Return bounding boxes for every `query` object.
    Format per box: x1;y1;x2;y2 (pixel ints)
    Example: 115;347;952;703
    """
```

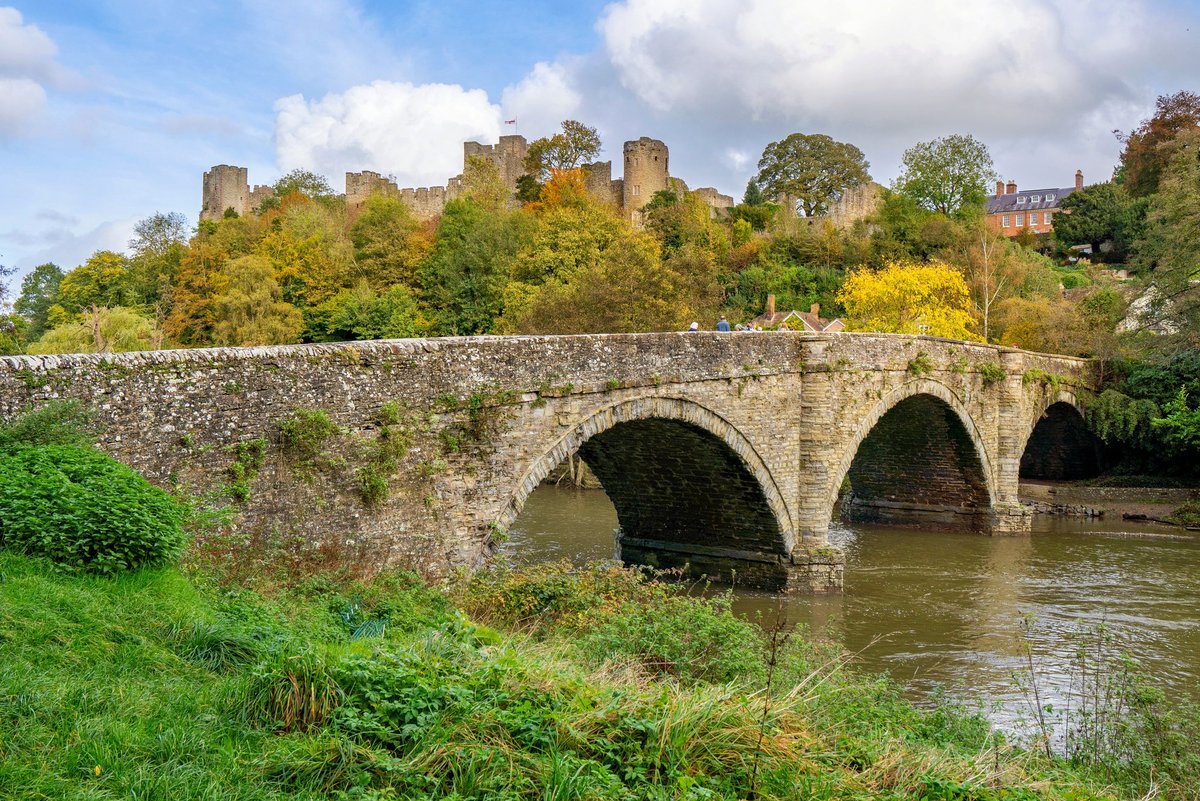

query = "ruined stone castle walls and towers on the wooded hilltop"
200;135;733;223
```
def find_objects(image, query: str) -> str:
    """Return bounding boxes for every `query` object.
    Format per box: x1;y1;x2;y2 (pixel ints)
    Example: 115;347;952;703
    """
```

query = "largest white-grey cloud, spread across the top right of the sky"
599;0;1195;135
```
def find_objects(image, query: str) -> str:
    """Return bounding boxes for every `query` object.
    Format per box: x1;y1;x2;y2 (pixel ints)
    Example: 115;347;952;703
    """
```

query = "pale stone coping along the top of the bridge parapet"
0;331;1094;372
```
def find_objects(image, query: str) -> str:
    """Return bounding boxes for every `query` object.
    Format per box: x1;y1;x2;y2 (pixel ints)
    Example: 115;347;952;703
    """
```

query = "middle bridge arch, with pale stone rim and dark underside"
827;379;996;531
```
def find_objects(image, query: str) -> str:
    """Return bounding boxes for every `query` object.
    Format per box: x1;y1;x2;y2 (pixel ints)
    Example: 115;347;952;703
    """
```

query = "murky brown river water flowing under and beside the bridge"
506;487;1200;717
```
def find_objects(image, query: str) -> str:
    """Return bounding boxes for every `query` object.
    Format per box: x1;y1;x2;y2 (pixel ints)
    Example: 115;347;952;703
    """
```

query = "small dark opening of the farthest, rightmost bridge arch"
1020;390;1103;481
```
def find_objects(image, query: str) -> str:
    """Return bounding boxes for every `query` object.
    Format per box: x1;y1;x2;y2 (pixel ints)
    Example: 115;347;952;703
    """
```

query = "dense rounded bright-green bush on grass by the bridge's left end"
0;445;185;574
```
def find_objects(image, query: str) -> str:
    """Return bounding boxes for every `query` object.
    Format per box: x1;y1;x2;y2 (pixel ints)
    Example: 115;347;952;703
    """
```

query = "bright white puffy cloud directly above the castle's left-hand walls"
275;80;503;187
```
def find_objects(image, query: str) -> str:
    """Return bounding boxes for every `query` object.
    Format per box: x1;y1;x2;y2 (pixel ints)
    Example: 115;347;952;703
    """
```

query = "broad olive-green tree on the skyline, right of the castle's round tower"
746;133;871;217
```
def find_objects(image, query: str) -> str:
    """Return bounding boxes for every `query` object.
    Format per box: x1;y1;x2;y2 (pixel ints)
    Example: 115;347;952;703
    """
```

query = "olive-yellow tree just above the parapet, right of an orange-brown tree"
212;255;304;347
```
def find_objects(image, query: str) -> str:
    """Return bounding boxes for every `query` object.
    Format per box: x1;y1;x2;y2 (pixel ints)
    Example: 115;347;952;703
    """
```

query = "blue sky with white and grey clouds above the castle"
0;0;1200;276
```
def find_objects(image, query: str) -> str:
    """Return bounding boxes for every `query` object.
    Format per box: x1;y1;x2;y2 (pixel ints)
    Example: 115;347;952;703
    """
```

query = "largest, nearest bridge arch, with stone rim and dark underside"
498;396;796;586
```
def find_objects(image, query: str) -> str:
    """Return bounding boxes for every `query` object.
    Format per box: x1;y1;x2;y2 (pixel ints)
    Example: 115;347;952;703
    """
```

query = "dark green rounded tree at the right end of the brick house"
1054;183;1146;261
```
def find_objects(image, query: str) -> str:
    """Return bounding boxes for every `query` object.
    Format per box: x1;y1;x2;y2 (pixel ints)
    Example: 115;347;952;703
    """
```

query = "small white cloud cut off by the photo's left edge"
0;6;67;135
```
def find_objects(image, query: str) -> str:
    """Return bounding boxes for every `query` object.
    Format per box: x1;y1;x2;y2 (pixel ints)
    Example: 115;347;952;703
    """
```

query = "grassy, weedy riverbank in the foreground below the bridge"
0;552;1188;800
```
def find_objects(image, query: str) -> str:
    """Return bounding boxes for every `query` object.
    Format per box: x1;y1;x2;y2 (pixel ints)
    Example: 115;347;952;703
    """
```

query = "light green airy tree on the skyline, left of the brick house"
893;133;996;215
